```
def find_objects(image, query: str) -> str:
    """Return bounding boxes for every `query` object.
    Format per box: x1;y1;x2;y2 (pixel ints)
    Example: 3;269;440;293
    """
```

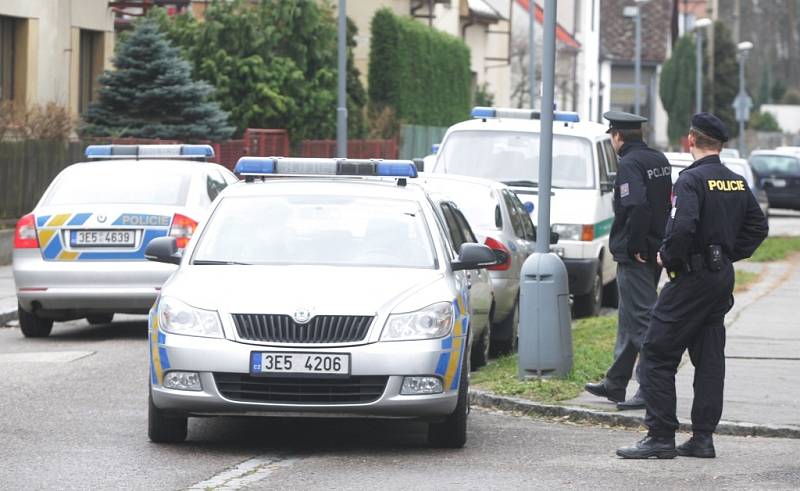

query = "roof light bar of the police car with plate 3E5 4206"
233;157;417;177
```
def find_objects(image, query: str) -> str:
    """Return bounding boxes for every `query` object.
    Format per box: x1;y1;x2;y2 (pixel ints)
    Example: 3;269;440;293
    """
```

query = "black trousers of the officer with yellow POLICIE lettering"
639;263;734;437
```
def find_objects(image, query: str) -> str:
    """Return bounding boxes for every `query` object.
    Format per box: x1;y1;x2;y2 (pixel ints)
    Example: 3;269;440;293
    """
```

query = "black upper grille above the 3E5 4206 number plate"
233;314;373;344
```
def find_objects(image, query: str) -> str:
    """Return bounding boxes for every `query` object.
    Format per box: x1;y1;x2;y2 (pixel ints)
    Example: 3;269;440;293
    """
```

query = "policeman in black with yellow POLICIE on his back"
617;113;768;459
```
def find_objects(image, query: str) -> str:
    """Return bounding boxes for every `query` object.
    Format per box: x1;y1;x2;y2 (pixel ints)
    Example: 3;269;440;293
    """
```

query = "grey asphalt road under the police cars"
0;317;800;489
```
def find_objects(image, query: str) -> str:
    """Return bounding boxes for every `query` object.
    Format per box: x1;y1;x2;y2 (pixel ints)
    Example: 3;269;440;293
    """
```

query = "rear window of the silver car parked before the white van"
426;179;500;230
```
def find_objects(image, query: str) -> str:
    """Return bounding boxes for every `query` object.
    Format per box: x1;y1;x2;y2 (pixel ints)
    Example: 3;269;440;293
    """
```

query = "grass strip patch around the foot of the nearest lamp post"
470;316;617;403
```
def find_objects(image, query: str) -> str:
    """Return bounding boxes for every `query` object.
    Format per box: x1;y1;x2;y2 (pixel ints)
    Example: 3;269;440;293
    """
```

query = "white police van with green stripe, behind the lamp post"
430;107;617;316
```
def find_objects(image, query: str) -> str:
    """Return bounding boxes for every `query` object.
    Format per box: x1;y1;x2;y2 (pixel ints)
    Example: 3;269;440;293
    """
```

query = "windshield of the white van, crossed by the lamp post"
437;130;594;189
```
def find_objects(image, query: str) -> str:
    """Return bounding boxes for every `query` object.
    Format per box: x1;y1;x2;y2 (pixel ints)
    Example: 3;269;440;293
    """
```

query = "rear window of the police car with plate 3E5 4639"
45;162;191;206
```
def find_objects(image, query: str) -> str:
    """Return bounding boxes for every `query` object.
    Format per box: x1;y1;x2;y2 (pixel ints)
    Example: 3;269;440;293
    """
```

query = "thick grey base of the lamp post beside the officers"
519;252;572;378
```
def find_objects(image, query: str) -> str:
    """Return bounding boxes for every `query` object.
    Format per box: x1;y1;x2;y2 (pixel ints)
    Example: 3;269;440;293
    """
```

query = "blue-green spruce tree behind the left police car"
82;19;233;140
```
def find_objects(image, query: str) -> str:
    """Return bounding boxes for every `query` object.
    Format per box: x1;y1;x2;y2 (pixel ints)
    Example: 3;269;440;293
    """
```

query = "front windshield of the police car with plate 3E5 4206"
194;196;436;268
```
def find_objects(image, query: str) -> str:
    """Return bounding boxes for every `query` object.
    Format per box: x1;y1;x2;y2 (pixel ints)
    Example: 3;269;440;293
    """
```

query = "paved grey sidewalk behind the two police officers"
566;256;800;430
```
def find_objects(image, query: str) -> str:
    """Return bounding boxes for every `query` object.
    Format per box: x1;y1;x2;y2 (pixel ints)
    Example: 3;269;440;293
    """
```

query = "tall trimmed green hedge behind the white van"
369;9;472;126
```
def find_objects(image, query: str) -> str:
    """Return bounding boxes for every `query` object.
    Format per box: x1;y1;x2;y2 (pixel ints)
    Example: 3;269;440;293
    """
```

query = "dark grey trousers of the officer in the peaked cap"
606;261;661;394
